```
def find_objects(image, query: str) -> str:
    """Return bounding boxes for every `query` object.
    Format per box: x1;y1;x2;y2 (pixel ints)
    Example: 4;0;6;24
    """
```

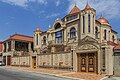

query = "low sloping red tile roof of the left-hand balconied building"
4;34;33;42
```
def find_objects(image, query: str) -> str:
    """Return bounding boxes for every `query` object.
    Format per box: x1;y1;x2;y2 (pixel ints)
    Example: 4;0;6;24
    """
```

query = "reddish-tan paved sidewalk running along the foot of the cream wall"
5;66;102;80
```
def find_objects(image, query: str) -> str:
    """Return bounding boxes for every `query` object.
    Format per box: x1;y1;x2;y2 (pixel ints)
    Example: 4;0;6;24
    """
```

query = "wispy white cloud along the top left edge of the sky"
2;0;47;7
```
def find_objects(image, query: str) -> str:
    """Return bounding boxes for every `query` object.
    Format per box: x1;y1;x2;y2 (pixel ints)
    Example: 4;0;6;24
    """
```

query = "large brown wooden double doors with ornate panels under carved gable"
79;53;97;73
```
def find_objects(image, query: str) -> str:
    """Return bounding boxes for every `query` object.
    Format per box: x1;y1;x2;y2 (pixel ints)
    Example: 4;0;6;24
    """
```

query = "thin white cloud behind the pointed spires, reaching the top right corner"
67;0;120;19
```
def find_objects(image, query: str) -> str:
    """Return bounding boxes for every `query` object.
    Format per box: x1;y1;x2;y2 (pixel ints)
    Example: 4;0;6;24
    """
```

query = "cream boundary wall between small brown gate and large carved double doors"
38;53;72;67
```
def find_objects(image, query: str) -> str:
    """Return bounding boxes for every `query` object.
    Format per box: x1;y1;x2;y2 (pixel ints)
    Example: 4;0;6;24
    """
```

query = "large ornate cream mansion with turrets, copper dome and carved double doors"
32;4;118;75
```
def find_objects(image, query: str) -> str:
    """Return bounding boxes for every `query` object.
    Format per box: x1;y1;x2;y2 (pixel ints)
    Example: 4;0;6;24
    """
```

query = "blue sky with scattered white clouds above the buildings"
0;0;120;41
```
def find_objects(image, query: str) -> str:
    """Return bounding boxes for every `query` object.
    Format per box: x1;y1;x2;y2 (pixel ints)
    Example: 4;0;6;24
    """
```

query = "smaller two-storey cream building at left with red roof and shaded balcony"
2;34;33;67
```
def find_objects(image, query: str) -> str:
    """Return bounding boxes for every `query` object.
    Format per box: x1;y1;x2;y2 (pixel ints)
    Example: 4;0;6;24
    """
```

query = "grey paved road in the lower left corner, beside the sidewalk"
0;68;77;80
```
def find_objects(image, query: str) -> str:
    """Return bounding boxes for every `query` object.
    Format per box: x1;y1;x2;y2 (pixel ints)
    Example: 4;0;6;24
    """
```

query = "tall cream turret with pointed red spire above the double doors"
81;3;96;37
